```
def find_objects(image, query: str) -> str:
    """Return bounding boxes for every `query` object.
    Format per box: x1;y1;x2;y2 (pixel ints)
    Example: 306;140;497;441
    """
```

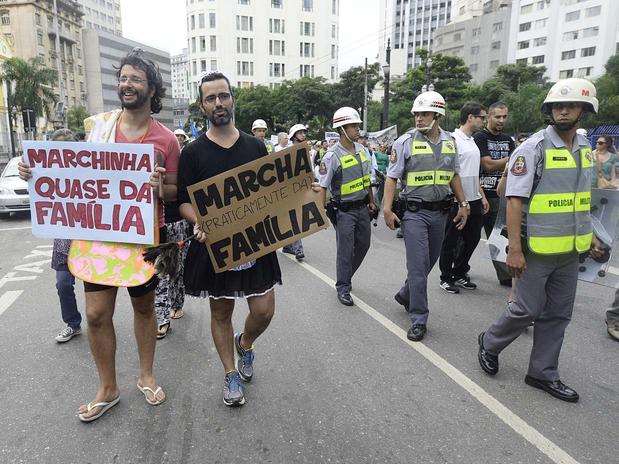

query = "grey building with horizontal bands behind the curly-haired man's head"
82;29;174;128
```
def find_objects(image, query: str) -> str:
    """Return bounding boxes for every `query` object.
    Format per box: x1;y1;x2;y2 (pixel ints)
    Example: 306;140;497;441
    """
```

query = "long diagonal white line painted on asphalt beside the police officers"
280;252;578;464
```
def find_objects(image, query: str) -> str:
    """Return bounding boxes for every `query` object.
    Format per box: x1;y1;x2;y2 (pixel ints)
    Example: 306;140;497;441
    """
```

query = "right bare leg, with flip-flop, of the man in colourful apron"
131;290;165;402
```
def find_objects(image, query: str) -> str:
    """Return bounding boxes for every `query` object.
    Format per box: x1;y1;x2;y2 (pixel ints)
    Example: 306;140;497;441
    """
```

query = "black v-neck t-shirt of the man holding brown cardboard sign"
178;131;268;204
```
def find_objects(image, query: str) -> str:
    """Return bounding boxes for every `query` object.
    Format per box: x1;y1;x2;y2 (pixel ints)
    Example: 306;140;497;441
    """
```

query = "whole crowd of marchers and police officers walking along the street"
20;50;619;422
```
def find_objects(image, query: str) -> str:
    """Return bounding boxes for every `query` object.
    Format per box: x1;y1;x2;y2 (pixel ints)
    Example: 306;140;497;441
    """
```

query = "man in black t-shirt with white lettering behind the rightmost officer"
473;102;515;286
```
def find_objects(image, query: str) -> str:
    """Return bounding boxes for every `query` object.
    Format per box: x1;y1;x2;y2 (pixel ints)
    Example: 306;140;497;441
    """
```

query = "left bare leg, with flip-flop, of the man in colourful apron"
79;288;120;417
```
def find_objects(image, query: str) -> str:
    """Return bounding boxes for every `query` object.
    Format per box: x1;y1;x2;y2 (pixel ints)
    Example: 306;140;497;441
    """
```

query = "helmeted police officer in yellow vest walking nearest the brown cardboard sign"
319;106;378;306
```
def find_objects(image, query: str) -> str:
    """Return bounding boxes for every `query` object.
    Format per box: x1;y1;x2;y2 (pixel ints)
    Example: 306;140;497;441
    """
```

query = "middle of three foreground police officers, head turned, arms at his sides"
383;92;469;341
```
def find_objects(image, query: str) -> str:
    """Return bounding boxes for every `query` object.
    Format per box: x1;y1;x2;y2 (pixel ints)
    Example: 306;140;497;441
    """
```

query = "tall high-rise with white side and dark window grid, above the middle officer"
378;0;452;75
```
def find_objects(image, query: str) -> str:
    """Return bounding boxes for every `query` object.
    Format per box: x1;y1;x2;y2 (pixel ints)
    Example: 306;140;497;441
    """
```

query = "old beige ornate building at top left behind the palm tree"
0;0;86;131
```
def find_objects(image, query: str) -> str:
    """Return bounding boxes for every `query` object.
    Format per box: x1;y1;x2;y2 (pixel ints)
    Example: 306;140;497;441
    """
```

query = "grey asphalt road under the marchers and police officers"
0;211;619;464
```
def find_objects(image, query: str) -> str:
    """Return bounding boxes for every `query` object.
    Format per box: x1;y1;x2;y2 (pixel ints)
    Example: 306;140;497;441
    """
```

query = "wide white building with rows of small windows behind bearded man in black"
186;0;339;98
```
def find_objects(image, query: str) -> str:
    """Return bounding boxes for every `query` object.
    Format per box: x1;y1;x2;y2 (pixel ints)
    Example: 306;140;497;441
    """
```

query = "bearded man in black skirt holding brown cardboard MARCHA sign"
179;72;326;406
